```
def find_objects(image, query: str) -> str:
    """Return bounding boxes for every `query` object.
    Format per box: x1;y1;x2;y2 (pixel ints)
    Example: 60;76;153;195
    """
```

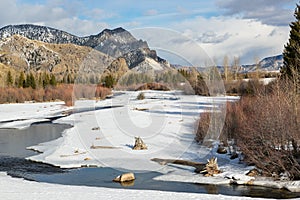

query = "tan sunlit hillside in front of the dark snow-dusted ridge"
0;35;114;79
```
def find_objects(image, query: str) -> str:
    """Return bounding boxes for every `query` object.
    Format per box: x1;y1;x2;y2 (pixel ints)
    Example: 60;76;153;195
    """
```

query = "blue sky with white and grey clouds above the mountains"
0;0;299;64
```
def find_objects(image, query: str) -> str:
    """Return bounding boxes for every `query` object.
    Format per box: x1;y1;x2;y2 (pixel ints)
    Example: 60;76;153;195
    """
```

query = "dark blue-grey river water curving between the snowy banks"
0;123;300;198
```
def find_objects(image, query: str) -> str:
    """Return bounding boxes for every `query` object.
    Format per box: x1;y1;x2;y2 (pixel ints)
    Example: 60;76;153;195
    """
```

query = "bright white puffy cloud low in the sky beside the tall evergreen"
180;17;289;63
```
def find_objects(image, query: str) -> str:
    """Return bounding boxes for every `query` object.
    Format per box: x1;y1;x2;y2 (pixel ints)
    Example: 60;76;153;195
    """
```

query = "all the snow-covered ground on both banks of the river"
0;91;299;199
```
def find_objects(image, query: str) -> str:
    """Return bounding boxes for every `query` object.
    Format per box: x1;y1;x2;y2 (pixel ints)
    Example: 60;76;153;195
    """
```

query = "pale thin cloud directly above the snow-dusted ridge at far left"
0;0;109;36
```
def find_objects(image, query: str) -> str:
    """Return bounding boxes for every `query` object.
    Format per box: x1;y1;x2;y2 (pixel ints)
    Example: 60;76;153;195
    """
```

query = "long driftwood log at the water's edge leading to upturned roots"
151;158;206;173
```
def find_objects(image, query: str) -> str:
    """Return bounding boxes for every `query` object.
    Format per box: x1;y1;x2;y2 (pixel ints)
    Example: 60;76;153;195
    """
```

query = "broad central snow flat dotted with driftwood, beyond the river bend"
29;91;237;171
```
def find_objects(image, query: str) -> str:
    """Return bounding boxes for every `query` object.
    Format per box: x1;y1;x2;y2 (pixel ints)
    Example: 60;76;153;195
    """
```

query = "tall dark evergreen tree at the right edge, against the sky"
281;5;300;79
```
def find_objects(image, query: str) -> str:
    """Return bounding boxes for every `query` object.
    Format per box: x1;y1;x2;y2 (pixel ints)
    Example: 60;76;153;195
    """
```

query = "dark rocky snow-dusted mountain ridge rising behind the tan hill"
0;24;169;69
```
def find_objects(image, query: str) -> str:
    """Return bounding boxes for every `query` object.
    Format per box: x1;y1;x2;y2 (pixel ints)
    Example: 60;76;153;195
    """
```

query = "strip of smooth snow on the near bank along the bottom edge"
0;172;270;200
